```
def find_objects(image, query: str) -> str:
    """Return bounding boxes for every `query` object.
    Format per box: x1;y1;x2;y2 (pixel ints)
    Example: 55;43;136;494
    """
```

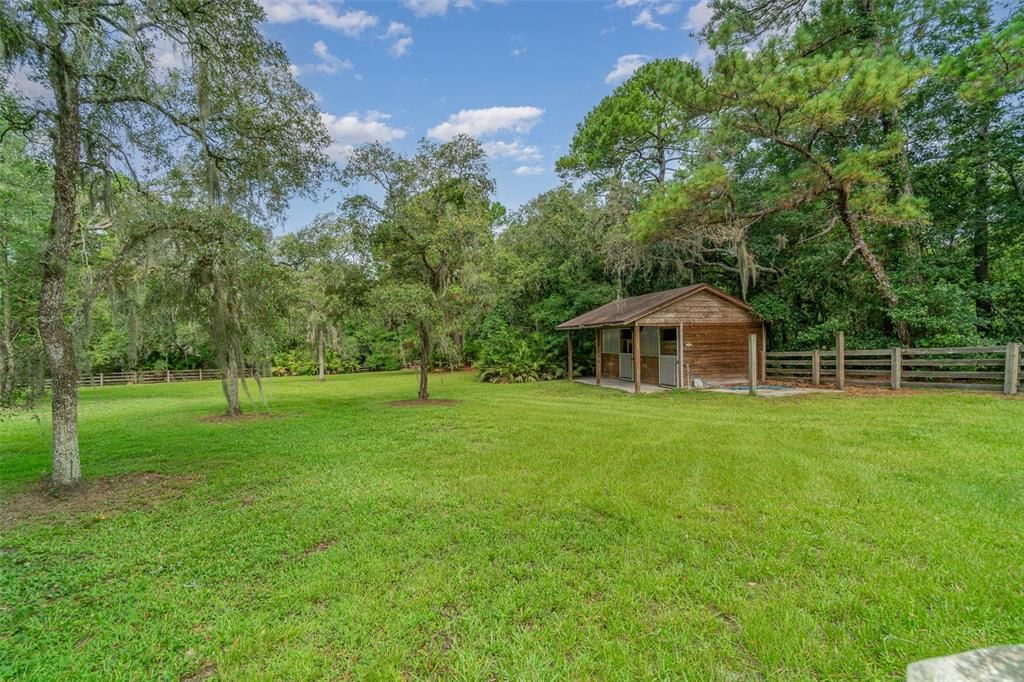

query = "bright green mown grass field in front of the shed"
0;374;1024;680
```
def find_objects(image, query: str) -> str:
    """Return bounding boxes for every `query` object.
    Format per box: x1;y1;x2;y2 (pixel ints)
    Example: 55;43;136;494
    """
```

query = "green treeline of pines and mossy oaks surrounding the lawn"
0;0;1024;482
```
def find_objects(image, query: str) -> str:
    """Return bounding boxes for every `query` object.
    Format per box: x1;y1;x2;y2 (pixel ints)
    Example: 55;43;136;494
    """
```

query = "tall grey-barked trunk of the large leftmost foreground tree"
39;55;82;486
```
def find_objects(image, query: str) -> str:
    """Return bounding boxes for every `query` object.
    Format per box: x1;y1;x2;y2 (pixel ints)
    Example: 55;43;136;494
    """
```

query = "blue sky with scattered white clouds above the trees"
261;0;708;230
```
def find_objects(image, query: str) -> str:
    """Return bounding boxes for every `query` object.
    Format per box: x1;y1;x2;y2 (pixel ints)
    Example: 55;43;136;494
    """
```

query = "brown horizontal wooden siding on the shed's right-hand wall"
683;319;763;384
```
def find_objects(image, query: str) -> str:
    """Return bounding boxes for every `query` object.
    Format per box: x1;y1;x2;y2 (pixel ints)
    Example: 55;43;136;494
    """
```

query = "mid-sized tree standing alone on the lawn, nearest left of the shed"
342;135;504;399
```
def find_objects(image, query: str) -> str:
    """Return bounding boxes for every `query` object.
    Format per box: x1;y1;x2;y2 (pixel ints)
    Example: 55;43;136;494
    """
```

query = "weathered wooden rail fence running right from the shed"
765;334;1024;395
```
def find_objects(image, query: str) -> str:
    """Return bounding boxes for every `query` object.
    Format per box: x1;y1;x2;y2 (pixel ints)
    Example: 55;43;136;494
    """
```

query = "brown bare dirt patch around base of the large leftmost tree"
0;472;197;528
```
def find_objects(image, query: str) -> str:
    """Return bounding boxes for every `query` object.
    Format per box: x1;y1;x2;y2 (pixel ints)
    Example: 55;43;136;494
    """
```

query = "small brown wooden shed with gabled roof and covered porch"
557;284;765;392
